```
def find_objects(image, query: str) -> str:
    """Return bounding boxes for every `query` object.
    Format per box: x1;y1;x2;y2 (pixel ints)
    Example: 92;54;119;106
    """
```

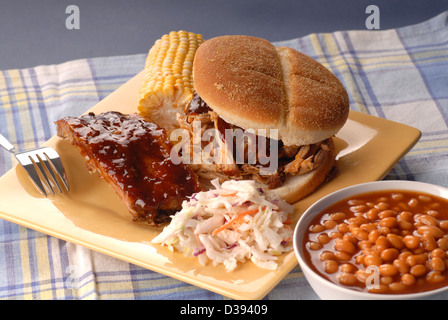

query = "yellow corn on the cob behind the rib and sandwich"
138;30;204;129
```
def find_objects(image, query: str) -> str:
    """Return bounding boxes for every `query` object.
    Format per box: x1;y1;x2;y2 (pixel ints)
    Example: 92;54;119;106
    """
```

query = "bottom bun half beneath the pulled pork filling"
272;139;335;204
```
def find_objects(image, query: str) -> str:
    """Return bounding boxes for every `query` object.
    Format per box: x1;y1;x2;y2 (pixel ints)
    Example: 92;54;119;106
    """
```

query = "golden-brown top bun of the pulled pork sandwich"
193;35;349;146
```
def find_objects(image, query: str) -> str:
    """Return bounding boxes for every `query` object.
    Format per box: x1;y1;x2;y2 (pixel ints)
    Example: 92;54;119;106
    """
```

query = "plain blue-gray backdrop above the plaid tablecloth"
0;0;448;69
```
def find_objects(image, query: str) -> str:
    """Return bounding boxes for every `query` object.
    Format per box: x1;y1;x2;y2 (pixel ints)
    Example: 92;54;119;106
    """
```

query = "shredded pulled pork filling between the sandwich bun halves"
178;94;330;189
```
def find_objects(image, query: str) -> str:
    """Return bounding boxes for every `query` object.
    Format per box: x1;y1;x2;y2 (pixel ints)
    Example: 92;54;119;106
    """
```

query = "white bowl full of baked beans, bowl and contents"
294;180;448;299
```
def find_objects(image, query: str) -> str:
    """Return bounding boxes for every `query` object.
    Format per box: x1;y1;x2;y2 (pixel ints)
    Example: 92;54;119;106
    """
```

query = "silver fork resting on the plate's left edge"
0;134;69;196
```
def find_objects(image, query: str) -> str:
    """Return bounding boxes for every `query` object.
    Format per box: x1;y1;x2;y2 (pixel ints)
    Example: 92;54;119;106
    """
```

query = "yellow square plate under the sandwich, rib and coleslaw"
0;73;420;299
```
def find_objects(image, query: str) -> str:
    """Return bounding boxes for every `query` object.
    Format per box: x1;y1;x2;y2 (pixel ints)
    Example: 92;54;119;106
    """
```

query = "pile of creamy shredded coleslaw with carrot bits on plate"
152;179;294;271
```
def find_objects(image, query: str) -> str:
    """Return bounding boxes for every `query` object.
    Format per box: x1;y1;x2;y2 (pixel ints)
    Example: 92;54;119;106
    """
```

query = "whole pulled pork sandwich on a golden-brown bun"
177;36;349;202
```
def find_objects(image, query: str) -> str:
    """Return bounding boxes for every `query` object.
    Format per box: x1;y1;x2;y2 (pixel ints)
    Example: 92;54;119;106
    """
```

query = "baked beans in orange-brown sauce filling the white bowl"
305;191;448;293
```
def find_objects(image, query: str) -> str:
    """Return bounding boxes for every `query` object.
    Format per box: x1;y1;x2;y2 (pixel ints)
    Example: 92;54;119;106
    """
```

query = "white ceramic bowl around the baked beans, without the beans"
294;180;448;300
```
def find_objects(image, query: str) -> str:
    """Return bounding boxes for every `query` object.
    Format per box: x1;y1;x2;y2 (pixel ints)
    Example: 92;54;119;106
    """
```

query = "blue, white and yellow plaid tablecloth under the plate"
0;12;448;300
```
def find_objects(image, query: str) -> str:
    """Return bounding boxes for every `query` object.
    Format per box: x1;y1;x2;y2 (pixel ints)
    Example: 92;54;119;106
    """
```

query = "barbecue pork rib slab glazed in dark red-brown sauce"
55;111;202;225
